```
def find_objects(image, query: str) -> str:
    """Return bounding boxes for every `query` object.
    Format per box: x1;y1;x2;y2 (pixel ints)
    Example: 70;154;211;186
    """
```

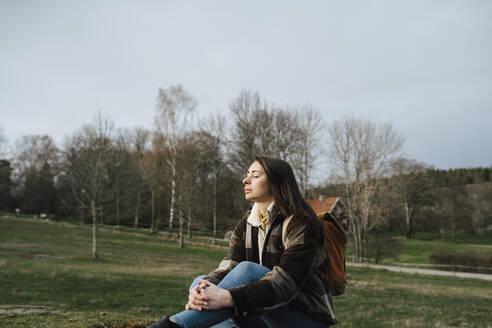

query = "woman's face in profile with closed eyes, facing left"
243;161;273;202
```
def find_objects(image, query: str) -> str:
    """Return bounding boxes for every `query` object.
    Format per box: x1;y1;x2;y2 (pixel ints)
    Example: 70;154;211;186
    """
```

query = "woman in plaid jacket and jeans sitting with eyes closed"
148;156;337;328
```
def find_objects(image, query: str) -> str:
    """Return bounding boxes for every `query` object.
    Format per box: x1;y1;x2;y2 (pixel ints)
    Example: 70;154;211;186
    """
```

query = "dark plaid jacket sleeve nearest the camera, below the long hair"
227;220;325;316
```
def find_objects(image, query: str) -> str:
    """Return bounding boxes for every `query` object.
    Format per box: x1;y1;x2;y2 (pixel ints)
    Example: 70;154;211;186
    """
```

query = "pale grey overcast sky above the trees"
0;0;492;181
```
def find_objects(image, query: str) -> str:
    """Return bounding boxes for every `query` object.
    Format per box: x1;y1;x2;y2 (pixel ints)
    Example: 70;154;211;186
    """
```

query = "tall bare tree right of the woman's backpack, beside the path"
327;117;404;262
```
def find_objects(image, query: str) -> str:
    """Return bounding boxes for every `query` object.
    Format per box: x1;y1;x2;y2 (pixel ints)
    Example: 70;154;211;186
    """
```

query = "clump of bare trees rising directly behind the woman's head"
227;90;324;211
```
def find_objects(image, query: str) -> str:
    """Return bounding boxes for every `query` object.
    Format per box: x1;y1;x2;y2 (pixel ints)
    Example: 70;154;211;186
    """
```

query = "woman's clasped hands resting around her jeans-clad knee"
185;279;234;311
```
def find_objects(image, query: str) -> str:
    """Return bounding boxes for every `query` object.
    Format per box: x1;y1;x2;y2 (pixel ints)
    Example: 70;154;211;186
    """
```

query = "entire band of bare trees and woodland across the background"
0;85;492;261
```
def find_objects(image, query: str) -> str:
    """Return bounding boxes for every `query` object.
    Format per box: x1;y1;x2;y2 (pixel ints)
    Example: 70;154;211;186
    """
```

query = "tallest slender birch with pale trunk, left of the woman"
155;85;197;228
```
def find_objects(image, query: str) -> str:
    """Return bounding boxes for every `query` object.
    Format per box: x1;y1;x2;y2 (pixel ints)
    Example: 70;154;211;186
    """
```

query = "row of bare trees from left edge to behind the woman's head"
0;85;323;246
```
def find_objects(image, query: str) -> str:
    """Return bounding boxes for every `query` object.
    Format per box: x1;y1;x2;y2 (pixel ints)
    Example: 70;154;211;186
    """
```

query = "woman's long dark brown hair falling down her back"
255;155;324;243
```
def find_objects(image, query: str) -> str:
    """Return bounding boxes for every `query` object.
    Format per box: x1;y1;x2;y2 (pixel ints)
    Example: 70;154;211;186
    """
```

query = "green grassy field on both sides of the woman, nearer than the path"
0;217;492;328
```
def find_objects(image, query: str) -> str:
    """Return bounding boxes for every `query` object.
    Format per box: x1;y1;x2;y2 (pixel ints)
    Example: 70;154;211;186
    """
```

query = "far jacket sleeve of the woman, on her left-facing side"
203;218;246;285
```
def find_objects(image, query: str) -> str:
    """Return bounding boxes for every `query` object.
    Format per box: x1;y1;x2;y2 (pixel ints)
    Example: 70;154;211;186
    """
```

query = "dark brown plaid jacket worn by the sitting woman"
205;204;337;325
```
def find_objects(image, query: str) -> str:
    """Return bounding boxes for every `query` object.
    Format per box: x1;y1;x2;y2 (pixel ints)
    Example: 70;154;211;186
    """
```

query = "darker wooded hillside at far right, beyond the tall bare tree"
313;159;492;240
